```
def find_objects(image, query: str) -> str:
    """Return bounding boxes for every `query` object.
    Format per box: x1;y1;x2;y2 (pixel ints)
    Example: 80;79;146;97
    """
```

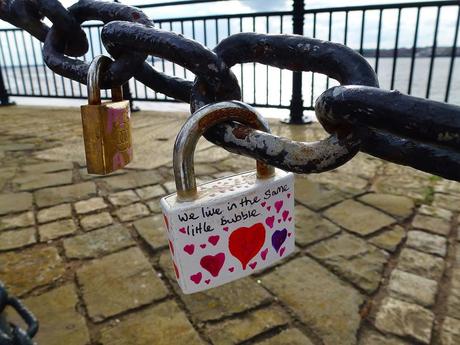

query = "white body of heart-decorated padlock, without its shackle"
161;169;295;294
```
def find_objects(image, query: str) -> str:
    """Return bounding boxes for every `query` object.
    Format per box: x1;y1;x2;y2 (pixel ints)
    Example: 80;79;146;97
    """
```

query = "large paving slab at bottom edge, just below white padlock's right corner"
261;257;364;345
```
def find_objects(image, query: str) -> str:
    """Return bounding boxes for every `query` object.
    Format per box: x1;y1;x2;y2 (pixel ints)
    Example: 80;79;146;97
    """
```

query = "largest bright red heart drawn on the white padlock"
228;223;264;270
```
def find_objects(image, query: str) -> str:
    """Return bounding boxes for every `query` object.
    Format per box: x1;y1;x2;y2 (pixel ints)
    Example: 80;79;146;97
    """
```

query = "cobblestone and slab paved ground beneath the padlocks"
0;107;460;345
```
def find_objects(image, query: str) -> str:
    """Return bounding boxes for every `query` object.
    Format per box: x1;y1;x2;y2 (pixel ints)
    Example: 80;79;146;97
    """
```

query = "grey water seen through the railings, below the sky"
3;57;460;116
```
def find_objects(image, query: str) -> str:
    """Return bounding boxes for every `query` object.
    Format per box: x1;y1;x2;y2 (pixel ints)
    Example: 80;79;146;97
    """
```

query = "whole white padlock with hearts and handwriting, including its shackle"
161;101;295;294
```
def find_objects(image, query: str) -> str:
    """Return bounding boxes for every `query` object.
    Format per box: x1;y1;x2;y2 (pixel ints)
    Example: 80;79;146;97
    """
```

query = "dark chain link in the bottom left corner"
0;282;38;345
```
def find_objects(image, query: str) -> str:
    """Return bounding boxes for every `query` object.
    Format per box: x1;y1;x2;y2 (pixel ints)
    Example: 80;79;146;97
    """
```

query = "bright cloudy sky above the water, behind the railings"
0;0;458;48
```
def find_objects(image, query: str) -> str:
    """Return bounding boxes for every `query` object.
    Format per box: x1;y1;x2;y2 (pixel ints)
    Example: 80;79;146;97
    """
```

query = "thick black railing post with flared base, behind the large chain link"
283;0;312;125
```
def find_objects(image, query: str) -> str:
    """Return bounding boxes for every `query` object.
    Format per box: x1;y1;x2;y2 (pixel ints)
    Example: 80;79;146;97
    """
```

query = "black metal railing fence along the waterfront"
0;0;460;115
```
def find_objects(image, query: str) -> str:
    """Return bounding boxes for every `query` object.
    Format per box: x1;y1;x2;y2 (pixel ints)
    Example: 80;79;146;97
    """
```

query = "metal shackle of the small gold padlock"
86;55;123;105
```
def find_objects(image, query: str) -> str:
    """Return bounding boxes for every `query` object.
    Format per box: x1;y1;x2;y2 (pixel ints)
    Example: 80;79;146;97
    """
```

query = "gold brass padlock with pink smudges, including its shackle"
81;55;133;175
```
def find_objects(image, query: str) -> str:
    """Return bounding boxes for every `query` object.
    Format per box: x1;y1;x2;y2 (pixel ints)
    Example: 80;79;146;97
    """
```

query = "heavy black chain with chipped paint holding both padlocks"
0;0;460;181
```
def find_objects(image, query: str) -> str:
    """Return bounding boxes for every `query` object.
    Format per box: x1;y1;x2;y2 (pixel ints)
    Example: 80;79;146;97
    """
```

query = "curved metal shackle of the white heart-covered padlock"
173;101;275;201
